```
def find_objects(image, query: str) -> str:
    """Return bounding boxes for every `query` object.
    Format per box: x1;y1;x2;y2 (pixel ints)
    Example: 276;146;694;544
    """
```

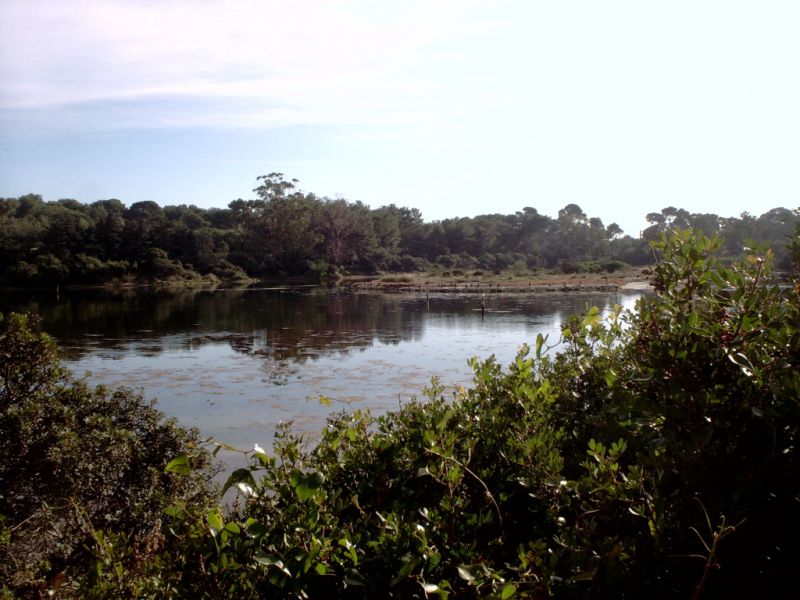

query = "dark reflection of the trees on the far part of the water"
0;289;636;366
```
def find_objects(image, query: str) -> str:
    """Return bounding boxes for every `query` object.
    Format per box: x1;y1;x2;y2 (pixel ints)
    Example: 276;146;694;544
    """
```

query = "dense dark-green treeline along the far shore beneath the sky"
0;173;797;285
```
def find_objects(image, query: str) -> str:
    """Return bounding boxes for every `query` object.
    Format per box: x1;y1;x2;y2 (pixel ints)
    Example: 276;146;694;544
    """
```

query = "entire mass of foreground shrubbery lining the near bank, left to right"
0;226;800;599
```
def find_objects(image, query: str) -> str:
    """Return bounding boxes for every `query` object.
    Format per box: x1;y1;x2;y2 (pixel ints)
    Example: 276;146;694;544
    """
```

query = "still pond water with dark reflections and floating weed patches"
0;288;639;448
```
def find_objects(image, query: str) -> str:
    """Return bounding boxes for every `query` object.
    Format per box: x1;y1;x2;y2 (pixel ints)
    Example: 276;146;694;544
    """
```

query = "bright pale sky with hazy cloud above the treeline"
0;0;800;236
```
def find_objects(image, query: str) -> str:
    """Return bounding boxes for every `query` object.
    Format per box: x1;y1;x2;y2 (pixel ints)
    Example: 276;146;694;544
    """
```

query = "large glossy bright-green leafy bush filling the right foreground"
153;233;800;598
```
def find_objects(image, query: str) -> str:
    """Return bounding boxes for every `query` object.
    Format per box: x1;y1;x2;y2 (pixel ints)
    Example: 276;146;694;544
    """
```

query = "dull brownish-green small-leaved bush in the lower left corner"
0;314;216;598
